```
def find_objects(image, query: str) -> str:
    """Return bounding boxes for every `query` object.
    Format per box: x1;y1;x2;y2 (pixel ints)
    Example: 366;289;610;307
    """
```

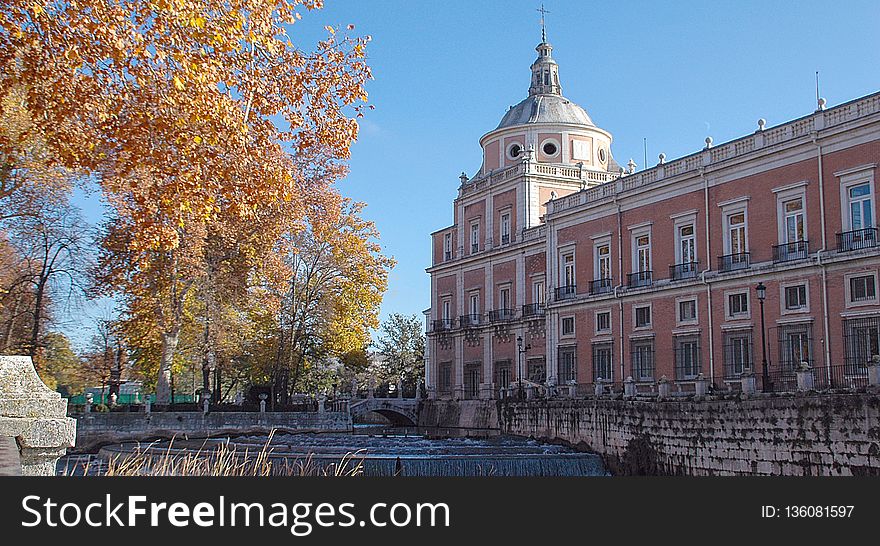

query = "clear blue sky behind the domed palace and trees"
63;0;880;346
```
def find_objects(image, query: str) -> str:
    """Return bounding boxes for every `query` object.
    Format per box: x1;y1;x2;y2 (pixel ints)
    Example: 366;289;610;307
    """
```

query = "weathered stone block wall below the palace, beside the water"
498;393;880;476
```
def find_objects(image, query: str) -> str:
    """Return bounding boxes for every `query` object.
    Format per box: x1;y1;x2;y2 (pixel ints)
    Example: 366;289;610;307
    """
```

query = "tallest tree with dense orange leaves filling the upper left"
0;0;370;402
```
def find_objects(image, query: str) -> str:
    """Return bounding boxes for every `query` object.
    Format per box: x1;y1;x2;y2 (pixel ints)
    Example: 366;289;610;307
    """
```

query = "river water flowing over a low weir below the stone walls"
59;429;607;476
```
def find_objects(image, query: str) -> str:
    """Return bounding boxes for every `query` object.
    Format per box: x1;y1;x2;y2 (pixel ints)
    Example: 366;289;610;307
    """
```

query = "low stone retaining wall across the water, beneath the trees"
76;412;351;451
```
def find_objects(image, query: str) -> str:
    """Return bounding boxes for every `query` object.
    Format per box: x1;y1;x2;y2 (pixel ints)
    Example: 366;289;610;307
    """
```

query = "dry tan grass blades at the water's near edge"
97;430;363;476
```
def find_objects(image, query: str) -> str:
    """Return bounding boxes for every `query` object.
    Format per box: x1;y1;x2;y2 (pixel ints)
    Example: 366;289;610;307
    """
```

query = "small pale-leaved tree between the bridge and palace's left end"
376;313;425;384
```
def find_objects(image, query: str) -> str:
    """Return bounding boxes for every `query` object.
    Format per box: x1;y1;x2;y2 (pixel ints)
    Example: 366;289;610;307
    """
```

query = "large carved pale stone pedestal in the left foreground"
0;356;76;476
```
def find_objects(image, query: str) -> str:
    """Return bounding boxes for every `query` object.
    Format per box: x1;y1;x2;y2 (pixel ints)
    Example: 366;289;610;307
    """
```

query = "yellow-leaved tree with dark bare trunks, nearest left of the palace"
272;193;394;403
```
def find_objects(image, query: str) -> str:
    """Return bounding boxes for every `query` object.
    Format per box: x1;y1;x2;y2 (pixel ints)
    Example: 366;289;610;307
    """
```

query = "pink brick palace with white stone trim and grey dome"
425;37;880;399
